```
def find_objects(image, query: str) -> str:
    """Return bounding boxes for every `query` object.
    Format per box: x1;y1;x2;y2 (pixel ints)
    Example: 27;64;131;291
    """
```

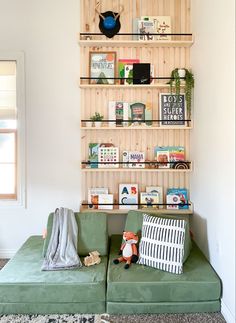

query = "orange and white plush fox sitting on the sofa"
113;231;138;269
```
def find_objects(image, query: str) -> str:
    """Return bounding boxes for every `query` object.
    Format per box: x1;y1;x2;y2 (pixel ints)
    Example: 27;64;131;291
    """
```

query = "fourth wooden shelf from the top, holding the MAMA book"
81;165;192;173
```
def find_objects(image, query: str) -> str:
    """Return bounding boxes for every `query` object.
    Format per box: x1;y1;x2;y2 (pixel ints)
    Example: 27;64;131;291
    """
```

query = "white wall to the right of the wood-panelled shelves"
191;0;235;322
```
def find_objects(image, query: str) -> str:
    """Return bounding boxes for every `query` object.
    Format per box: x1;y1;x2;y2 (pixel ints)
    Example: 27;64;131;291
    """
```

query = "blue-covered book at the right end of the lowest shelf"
166;188;189;210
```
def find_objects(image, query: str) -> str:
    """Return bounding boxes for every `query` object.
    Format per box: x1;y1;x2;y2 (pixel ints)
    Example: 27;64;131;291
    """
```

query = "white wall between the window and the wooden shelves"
0;0;80;255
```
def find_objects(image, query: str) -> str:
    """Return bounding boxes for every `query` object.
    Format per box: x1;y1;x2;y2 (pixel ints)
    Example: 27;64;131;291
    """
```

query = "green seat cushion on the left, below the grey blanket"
0;236;107;307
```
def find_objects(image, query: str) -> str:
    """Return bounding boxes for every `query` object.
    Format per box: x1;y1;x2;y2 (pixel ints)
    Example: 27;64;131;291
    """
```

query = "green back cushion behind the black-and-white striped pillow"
125;210;192;262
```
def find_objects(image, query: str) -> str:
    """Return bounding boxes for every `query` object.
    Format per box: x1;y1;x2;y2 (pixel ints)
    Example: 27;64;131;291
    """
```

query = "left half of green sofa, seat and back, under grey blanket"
0;213;108;314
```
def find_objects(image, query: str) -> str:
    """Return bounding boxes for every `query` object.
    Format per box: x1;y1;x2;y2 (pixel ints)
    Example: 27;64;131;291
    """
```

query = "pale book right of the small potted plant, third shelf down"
108;101;129;127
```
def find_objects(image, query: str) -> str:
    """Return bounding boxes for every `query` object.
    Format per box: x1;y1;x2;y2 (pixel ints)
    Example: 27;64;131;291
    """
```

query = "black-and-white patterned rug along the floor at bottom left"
0;314;110;323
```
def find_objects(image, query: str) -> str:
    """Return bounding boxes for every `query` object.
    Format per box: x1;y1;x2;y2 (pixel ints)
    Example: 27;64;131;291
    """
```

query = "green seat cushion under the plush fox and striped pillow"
107;235;221;303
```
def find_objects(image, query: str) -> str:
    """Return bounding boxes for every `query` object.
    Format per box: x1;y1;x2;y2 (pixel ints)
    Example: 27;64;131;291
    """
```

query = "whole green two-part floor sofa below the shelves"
0;211;221;314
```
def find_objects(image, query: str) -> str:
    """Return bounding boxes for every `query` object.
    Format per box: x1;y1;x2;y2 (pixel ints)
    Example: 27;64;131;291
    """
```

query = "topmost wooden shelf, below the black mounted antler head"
78;38;194;48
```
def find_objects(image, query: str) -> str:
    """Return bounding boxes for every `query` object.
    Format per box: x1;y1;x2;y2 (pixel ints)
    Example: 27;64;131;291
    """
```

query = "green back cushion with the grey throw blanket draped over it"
43;212;108;256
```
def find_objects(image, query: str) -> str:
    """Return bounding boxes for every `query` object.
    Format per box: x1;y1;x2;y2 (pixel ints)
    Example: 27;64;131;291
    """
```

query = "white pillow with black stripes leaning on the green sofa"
138;214;186;274
